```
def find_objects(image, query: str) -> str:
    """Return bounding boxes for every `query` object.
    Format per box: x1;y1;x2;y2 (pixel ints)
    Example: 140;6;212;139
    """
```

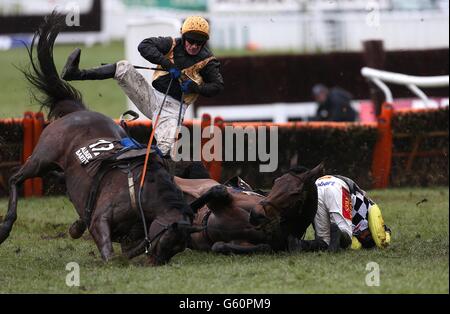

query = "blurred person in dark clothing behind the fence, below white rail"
310;84;356;121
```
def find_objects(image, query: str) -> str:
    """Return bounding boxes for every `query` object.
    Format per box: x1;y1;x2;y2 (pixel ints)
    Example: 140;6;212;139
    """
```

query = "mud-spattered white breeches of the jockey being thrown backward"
114;60;188;154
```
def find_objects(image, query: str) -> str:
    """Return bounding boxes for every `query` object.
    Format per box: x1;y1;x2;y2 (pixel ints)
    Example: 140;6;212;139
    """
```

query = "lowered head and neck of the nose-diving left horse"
147;157;202;266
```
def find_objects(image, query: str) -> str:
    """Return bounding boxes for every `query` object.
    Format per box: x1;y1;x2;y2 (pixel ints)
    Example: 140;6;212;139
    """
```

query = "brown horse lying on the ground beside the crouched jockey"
175;164;323;254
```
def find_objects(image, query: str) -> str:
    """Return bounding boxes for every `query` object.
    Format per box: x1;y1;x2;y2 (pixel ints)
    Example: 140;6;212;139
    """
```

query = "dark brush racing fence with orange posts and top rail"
0;103;448;196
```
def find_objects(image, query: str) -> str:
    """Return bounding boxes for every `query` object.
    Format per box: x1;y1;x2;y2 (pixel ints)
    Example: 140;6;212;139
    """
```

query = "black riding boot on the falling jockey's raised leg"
61;48;116;81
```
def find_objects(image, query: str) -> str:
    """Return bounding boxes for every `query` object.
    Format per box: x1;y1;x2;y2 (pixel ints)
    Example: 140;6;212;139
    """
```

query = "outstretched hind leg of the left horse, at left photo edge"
0;154;51;244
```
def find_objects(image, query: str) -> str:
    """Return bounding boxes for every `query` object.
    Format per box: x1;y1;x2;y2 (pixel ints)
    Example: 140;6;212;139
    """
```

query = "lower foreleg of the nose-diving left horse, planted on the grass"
89;213;114;262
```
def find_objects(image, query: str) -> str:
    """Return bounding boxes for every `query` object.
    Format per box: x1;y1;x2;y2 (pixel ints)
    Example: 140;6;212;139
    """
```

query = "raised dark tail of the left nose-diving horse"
22;11;86;119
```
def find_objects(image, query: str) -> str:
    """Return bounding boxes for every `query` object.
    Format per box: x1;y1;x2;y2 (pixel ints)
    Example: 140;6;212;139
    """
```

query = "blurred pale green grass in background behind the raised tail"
0;42;126;119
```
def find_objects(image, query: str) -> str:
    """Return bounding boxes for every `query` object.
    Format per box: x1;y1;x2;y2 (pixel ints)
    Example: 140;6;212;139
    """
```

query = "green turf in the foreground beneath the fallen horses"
0;187;449;293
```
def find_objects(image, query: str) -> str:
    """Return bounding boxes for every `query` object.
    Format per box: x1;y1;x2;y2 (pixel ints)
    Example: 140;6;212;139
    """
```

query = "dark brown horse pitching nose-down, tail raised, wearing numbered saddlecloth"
0;13;199;265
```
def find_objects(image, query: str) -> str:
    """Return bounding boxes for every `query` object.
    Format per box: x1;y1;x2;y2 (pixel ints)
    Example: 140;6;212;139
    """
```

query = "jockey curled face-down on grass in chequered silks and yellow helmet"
289;175;390;252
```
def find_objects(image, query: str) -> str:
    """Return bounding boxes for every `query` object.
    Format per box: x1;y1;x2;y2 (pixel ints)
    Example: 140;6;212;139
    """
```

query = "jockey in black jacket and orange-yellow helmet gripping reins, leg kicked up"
61;16;224;156
